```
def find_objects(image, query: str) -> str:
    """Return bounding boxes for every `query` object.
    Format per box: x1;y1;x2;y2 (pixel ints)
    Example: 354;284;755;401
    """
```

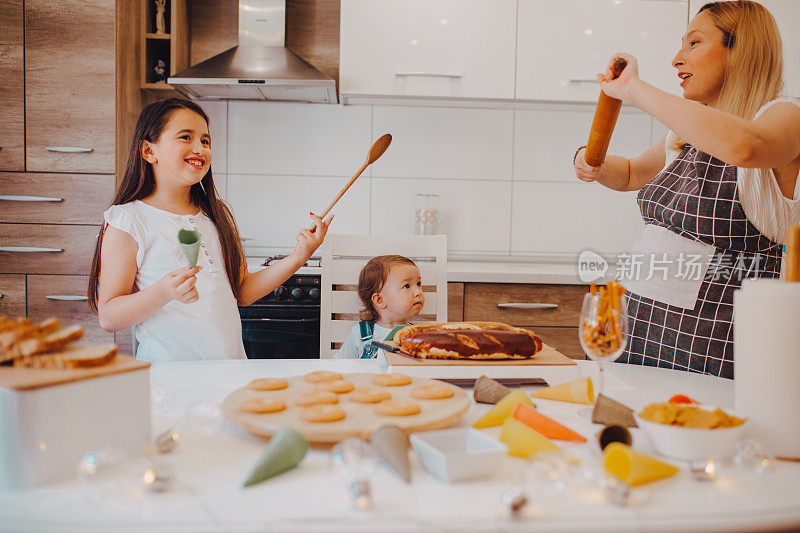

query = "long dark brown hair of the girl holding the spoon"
88;98;244;313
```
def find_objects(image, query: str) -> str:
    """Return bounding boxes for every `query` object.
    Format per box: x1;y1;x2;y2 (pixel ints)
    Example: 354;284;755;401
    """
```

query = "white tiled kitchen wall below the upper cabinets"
211;102;665;258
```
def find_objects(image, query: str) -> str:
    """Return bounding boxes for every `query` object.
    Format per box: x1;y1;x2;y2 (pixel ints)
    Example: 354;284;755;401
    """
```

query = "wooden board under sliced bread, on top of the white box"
0;355;150;391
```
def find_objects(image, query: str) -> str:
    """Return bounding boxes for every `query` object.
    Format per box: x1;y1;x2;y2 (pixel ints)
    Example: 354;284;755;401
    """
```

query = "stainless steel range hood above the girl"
168;0;337;104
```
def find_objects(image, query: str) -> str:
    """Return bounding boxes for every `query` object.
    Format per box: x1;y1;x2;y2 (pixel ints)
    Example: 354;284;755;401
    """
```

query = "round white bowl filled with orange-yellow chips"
633;406;747;461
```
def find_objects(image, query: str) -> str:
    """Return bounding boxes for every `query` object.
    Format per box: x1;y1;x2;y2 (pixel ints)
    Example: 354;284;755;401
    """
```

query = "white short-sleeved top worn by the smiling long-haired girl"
103;200;246;362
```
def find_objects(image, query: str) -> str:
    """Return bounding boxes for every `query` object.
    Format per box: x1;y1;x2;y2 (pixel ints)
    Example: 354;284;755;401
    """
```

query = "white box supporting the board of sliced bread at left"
0;364;150;489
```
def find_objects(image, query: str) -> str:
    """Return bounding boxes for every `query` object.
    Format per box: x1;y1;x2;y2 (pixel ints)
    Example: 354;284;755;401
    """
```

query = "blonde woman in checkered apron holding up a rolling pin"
575;1;800;378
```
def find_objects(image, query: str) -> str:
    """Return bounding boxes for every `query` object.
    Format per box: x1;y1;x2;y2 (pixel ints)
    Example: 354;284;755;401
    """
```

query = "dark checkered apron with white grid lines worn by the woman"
619;145;781;378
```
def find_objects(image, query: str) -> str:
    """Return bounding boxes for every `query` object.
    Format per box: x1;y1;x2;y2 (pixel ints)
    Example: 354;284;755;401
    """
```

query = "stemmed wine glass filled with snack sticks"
578;289;628;418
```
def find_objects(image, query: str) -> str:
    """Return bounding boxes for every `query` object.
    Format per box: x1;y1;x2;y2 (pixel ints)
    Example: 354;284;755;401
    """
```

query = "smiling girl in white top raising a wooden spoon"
89;98;332;361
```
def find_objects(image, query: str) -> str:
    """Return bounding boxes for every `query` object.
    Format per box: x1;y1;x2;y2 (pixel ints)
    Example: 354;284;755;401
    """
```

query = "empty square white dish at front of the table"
410;428;506;482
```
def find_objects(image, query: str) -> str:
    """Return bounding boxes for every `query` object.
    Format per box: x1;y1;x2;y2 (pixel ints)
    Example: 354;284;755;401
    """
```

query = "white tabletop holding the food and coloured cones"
0;360;800;533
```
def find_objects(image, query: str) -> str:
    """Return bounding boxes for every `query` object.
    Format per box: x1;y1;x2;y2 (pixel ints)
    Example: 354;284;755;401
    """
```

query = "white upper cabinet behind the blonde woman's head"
689;0;800;98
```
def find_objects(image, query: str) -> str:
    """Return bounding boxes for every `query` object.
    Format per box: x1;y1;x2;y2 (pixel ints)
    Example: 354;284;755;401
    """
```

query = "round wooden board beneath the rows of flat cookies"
221;374;471;443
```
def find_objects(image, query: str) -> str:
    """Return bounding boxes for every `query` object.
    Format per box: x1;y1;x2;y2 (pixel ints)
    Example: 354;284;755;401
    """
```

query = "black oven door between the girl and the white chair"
242;317;319;359
